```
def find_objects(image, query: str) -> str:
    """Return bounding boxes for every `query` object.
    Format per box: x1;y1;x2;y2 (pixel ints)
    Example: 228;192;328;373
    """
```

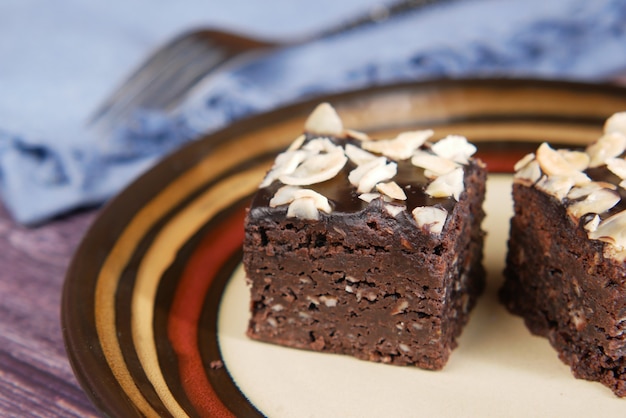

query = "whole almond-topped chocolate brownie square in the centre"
244;104;486;370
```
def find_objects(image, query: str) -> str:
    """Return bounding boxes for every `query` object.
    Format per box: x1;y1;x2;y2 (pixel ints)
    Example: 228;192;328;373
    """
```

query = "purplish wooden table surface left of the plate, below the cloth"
0;202;98;417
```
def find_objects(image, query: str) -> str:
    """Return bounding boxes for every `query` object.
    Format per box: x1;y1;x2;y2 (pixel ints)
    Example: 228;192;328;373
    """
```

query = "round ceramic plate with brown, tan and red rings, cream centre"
62;80;626;417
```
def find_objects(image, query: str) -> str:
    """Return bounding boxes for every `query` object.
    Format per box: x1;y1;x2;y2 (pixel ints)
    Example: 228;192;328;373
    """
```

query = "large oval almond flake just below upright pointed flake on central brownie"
278;147;348;186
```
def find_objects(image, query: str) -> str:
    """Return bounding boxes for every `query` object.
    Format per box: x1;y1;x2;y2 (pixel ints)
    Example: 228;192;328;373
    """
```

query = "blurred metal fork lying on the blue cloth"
89;0;443;128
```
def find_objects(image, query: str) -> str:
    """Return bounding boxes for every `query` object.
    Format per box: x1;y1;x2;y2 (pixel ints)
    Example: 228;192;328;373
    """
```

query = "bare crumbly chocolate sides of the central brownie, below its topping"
244;162;486;370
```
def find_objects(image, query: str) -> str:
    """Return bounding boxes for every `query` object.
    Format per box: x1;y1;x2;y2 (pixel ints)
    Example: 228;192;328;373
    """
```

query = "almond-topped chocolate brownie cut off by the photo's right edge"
500;112;626;397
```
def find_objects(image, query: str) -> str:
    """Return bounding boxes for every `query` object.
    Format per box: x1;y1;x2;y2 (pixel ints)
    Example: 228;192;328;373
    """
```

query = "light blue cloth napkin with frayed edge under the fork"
0;0;626;225
